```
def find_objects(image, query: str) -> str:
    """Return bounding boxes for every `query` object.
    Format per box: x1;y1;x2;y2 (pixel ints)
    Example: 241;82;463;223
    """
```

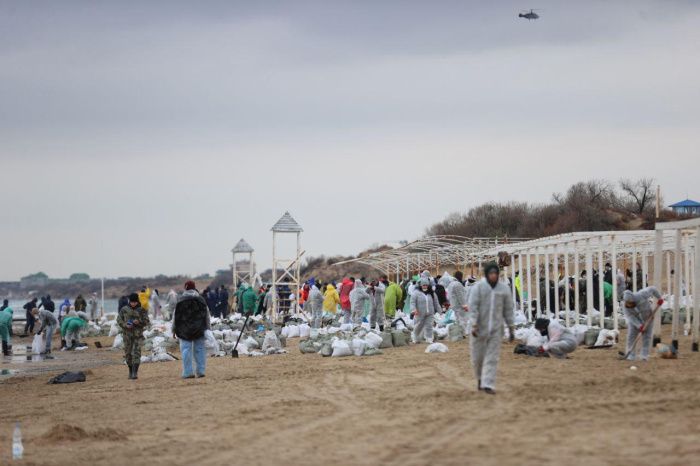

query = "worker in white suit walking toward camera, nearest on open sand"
469;262;515;395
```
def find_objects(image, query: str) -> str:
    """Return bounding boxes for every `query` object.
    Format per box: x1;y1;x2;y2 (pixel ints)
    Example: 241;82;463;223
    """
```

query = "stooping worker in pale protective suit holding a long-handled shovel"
622;286;664;361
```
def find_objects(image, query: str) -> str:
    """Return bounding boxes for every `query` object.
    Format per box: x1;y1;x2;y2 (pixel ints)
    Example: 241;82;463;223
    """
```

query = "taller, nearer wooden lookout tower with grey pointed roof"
270;212;305;319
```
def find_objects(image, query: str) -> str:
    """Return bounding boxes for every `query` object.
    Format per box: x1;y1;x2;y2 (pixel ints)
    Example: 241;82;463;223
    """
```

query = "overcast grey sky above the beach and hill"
0;0;700;280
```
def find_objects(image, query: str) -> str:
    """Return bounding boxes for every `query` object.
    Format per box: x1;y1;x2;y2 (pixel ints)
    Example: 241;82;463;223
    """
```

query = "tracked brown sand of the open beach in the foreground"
0;327;700;466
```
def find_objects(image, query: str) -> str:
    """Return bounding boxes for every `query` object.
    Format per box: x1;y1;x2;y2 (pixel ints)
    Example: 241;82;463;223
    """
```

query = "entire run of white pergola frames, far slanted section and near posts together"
337;229;700;350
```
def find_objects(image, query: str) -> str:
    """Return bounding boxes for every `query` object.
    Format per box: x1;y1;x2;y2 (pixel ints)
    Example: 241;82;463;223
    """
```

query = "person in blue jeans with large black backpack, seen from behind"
173;280;211;379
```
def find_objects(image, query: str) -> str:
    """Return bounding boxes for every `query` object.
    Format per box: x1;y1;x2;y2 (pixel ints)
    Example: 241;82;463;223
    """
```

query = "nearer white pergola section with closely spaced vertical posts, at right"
484;230;697;338
